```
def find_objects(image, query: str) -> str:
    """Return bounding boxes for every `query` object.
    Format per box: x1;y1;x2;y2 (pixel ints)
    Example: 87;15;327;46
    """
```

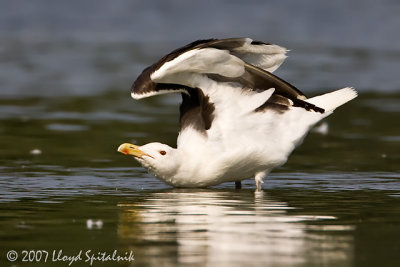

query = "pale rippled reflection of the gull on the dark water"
118;190;353;266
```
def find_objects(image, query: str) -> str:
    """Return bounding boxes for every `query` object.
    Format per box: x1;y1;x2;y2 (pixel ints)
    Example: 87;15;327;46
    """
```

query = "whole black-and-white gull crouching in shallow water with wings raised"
118;38;357;190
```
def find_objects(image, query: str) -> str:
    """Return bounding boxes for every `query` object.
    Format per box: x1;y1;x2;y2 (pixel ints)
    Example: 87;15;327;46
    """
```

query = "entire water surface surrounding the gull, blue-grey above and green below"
0;0;400;266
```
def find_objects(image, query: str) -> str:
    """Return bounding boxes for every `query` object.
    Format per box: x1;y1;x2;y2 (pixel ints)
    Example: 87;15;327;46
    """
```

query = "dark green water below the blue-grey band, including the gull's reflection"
0;89;400;266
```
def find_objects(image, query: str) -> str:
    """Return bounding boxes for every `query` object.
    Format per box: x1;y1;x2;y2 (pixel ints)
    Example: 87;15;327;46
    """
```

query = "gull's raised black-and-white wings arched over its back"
131;38;324;136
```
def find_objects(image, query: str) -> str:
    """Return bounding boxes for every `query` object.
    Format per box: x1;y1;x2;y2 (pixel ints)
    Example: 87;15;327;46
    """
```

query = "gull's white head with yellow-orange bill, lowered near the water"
118;143;181;180
